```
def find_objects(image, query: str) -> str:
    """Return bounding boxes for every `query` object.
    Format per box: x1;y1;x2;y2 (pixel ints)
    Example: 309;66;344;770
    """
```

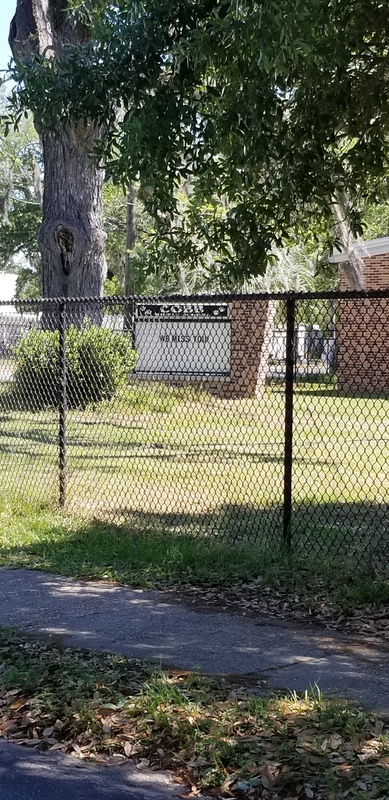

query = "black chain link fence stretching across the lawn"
0;291;389;570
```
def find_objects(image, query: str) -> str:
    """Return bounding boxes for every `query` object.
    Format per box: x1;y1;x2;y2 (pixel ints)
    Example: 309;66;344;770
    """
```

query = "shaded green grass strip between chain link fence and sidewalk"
0;498;389;618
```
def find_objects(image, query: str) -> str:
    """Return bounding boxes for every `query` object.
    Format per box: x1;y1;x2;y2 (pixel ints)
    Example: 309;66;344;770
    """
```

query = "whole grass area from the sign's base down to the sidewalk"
0;382;389;610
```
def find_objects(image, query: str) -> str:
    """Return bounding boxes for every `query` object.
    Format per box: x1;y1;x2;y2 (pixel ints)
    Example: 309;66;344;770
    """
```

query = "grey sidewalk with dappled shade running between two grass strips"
0;568;389;714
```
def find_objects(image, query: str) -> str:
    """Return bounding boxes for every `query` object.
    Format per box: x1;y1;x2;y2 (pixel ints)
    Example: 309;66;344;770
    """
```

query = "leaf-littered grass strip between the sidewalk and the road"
0;629;389;800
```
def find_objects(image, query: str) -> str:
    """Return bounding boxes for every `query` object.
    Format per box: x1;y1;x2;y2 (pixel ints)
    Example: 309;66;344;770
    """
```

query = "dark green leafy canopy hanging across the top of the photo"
6;0;389;283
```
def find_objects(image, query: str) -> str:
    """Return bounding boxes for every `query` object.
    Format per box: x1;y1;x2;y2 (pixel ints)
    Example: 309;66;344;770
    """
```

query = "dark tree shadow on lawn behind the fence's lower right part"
87;502;389;570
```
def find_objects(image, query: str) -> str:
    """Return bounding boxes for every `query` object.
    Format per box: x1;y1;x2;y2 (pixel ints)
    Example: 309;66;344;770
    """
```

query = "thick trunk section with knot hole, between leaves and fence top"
38;126;106;297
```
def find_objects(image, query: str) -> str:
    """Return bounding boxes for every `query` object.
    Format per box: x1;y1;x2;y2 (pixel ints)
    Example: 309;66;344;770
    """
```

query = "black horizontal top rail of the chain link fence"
0;288;389;308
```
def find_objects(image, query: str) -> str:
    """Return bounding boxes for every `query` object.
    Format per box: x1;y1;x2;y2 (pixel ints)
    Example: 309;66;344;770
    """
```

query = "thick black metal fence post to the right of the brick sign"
283;297;296;552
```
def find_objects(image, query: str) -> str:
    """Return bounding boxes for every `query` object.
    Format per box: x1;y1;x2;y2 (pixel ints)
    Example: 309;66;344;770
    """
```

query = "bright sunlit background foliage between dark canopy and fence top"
104;178;337;295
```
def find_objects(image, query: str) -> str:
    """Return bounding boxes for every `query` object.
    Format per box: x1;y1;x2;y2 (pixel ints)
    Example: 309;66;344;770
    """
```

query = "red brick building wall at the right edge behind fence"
338;253;389;394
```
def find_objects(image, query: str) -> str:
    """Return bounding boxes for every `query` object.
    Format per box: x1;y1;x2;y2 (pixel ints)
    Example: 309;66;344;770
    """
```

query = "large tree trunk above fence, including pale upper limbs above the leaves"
9;0;106;297
